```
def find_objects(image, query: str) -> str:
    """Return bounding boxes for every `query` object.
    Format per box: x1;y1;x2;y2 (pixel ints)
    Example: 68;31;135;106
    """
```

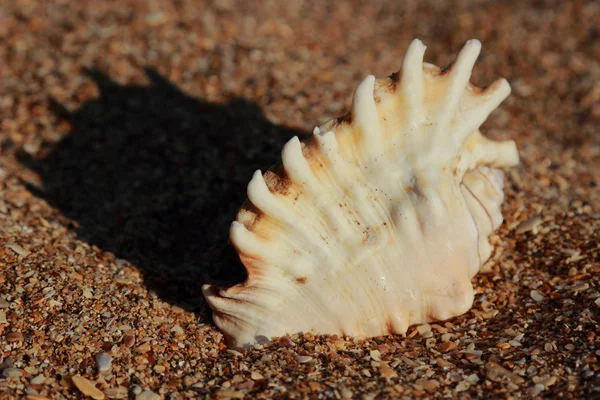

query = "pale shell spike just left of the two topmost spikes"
352;75;382;155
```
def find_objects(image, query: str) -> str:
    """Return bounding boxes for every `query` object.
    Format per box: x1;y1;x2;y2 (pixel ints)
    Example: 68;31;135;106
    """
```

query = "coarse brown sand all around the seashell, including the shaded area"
0;0;600;399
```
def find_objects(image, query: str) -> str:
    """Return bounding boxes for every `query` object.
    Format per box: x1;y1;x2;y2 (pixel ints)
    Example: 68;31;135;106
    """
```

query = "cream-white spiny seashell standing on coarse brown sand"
203;40;519;348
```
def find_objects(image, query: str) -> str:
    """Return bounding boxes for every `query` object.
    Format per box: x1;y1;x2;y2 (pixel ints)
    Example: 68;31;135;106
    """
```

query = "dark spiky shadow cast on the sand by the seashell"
20;69;303;311
